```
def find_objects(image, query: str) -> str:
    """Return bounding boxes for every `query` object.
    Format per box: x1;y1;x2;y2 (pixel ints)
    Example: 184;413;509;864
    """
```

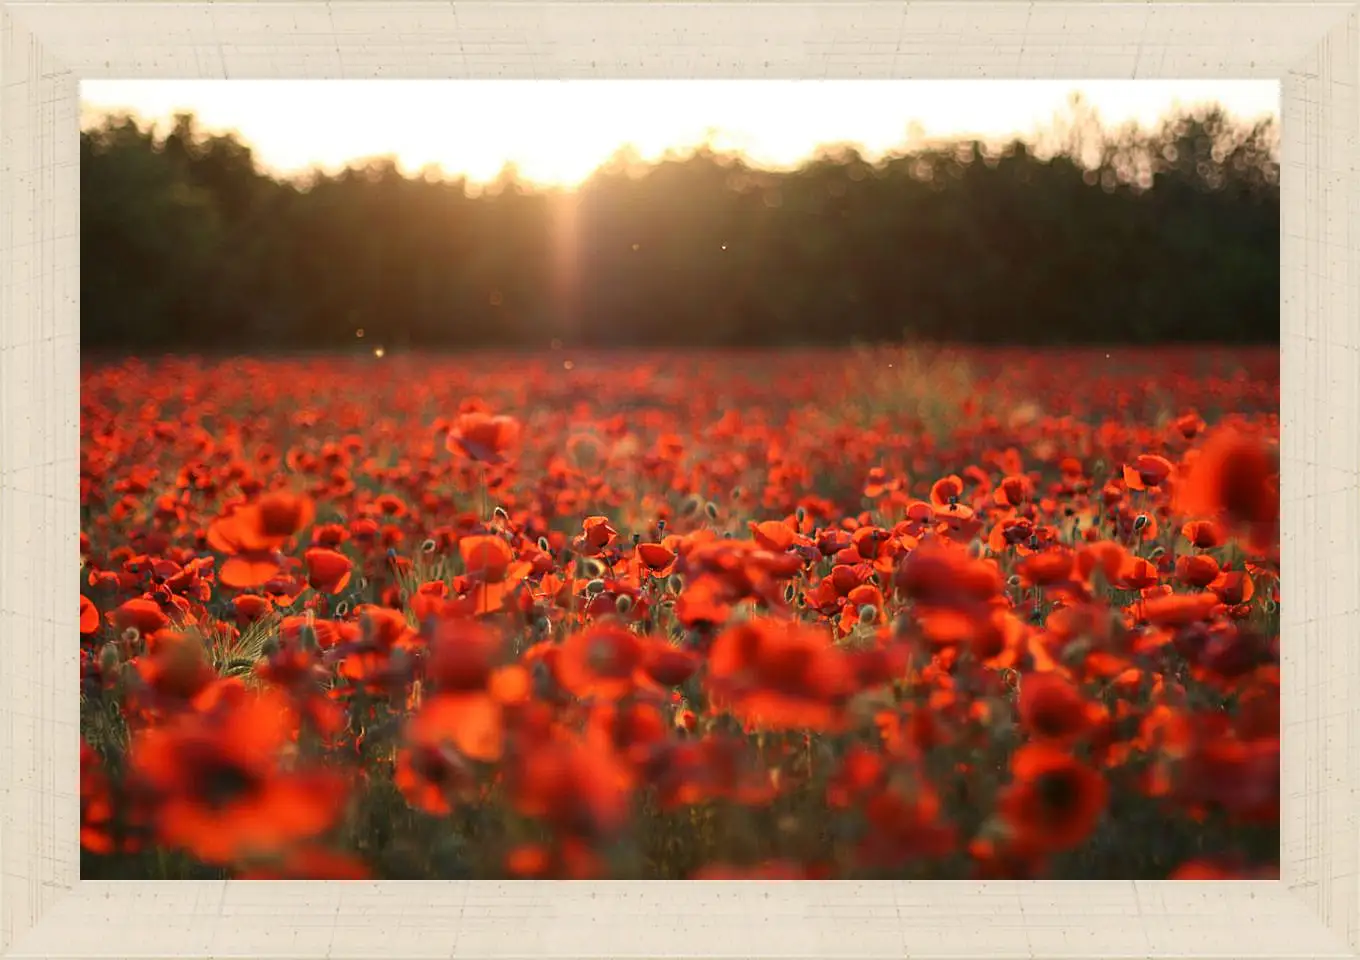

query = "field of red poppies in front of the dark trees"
72;347;1281;880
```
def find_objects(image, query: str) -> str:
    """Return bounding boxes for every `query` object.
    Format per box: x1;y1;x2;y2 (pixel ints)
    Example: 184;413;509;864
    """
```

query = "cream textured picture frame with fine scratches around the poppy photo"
0;0;1360;959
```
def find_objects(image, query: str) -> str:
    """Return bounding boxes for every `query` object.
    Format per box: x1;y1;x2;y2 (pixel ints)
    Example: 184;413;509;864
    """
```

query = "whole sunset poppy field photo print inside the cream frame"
79;80;1281;880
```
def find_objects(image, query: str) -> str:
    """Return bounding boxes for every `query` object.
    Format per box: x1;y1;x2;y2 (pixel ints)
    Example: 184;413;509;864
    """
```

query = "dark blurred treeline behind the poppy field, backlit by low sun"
80;99;1280;351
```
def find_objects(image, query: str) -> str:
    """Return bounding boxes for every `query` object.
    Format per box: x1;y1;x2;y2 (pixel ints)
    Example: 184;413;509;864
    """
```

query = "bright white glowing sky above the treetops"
80;80;1280;186
